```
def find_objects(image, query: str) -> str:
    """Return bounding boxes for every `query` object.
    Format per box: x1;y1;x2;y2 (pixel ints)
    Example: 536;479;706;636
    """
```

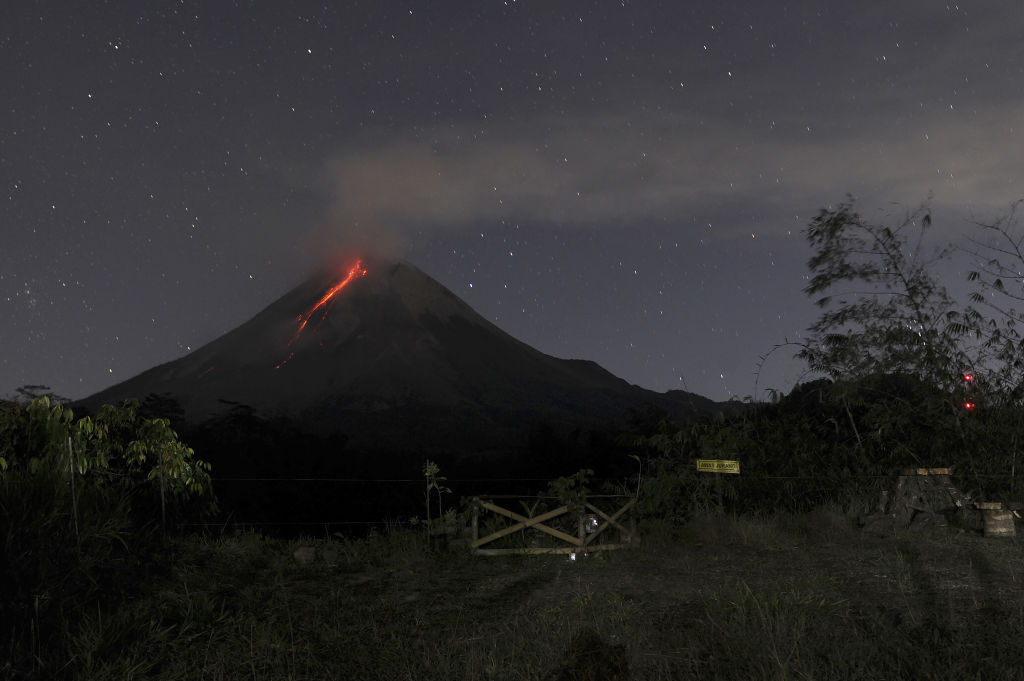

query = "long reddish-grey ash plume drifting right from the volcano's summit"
311;96;1024;250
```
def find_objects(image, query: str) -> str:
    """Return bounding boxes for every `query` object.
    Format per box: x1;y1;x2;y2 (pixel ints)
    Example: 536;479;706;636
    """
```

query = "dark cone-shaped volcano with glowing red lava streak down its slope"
83;258;718;452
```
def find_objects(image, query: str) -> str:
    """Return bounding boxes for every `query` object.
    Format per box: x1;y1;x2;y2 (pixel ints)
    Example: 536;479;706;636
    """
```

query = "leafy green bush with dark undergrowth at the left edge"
0;397;212;678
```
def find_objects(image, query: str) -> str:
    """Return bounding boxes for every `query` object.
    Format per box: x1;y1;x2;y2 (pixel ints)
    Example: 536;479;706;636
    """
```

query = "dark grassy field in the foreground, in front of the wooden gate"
18;512;1024;680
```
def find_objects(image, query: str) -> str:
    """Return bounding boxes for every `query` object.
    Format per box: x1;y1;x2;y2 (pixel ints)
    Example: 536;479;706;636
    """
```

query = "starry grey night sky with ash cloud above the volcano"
0;0;1024;399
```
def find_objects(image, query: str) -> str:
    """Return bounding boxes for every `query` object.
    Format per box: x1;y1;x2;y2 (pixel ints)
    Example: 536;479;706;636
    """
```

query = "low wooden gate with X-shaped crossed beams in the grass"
470;499;640;555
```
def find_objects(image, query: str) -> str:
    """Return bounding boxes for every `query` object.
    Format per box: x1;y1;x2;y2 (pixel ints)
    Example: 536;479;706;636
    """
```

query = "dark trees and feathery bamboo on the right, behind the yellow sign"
632;196;1024;517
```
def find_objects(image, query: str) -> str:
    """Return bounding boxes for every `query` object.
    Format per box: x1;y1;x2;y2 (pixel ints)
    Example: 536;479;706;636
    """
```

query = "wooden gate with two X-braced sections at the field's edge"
470;497;640;556
